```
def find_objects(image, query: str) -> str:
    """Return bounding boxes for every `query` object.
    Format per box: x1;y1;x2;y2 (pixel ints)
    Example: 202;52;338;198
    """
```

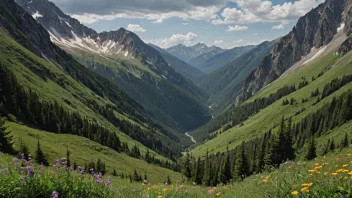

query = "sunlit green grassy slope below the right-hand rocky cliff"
192;52;352;156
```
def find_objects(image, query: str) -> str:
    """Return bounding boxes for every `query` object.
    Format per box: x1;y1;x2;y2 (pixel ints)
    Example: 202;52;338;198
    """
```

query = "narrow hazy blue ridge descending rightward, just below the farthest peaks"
149;44;205;82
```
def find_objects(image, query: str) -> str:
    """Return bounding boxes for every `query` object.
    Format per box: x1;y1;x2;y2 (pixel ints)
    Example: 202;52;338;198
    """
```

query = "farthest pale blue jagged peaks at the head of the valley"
165;43;224;63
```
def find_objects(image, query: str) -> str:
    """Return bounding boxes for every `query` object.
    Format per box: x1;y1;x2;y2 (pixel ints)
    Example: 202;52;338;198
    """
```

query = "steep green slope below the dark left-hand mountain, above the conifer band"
0;32;175;159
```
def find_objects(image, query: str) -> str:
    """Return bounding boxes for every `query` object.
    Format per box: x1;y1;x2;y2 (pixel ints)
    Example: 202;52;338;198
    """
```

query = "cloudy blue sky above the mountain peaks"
51;0;324;49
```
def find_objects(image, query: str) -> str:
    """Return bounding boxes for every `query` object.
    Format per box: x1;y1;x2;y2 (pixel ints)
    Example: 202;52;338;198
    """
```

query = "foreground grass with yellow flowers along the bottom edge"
0;147;352;198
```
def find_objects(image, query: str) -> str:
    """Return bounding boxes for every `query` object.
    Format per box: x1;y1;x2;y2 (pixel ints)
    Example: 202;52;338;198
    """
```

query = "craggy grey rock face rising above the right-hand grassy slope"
236;0;349;104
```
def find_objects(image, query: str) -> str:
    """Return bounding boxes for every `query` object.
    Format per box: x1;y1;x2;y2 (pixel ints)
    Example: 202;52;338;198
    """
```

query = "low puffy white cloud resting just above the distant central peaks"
150;32;198;48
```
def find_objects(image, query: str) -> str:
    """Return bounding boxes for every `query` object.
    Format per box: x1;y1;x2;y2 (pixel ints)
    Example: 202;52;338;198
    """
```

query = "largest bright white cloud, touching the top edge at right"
212;0;324;24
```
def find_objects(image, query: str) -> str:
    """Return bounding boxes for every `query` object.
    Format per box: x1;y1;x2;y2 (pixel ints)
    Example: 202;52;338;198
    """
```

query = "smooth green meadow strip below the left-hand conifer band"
6;122;182;183
